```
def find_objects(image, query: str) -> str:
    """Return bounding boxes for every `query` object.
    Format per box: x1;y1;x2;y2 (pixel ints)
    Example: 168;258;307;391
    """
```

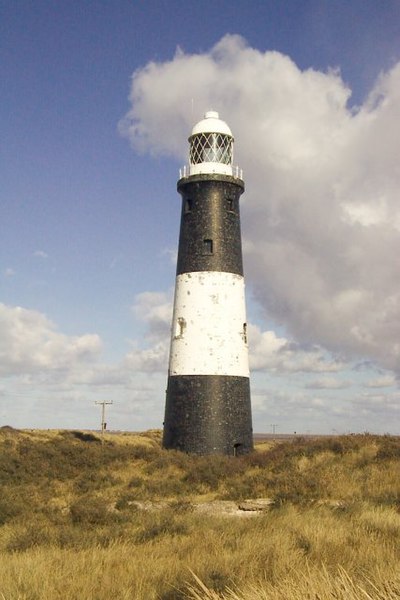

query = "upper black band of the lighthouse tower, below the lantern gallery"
176;174;244;275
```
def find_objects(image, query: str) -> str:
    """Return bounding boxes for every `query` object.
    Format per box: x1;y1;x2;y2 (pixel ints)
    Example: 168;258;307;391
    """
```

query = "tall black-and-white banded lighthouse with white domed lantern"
163;111;253;456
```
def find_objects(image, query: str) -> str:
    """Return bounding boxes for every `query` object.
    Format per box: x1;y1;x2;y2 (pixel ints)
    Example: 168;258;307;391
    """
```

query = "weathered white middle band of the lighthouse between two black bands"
169;271;249;377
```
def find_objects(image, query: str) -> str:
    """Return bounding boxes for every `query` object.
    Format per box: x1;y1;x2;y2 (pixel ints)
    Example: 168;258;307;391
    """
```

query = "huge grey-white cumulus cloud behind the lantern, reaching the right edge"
120;35;400;372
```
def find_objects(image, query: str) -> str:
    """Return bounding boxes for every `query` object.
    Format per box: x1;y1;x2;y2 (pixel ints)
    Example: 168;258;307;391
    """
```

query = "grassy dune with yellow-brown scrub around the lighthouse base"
0;428;400;600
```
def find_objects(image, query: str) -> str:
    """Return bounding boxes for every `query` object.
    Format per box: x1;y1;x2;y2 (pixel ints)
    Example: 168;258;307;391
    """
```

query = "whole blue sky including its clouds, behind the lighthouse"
0;0;400;433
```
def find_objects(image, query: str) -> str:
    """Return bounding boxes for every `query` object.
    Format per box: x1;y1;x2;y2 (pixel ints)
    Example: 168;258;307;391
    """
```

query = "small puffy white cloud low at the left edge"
0;304;101;376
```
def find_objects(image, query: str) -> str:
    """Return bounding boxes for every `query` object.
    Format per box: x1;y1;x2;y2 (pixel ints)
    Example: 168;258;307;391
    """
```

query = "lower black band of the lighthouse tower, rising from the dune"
163;375;253;456
